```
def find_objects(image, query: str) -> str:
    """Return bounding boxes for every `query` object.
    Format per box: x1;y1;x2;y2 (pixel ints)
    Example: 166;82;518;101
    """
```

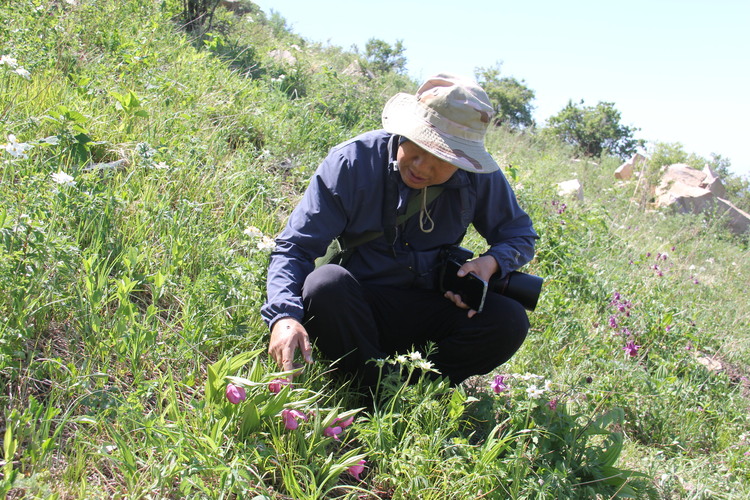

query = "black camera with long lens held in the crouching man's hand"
439;246;544;312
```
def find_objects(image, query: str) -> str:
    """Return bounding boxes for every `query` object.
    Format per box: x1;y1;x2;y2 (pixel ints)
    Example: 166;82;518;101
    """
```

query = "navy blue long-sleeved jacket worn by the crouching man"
261;130;537;326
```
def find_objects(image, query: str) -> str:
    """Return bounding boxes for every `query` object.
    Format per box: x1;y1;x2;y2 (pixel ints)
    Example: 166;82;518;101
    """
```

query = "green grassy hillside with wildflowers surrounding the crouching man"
0;0;750;499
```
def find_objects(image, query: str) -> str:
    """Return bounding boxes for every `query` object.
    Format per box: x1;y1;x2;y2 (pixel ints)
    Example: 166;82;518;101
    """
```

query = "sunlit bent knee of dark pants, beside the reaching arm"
302;264;358;310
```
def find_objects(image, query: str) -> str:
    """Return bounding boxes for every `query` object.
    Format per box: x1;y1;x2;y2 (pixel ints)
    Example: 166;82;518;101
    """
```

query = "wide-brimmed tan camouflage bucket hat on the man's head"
382;73;500;174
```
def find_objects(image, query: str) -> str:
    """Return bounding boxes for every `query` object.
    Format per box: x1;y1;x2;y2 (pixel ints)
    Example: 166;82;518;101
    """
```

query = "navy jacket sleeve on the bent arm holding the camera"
473;171;539;276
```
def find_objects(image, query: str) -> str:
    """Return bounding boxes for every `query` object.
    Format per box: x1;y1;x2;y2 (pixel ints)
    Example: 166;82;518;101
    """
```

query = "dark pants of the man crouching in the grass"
302;264;529;386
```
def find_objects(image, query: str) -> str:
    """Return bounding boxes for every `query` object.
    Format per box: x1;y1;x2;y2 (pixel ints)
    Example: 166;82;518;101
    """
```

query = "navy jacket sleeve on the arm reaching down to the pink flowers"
261;154;351;328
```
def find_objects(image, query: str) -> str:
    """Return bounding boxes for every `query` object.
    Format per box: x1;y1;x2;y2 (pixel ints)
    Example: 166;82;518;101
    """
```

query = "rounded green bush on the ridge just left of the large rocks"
547;100;645;159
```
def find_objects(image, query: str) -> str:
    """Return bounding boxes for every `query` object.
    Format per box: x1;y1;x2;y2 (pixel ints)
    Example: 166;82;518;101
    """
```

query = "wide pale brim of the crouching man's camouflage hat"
382;92;500;174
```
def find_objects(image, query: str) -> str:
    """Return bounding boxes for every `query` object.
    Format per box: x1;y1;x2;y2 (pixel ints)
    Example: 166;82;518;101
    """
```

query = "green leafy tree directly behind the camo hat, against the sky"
474;63;534;129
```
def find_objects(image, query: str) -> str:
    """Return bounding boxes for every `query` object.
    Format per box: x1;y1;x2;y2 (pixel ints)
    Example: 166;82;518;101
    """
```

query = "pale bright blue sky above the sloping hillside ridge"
254;0;750;175
